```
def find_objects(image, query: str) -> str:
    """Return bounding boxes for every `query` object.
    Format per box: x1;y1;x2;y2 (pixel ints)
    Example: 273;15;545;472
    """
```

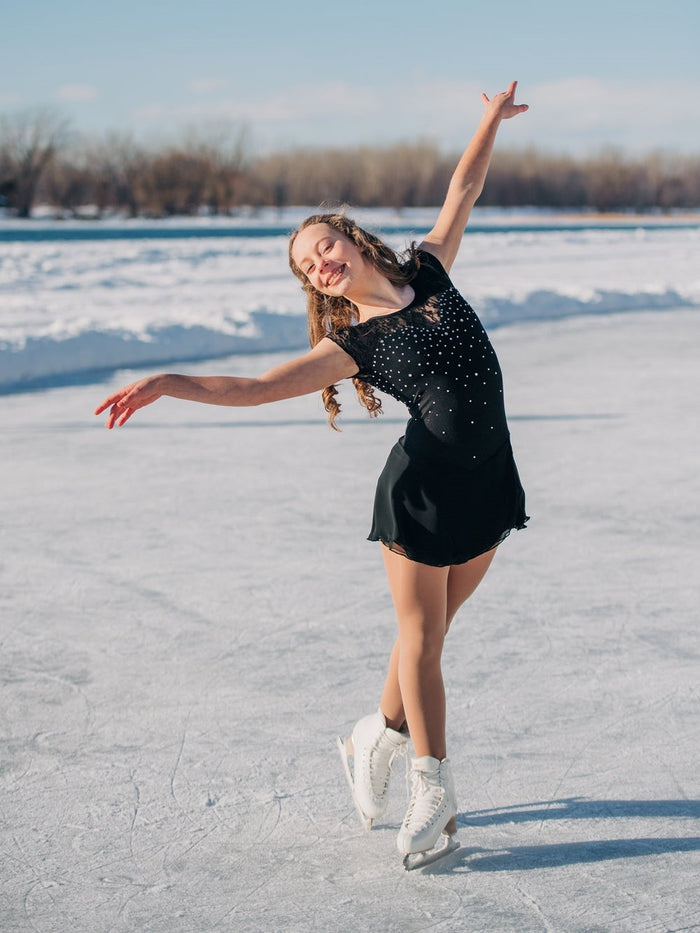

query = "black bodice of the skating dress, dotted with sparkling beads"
329;251;508;466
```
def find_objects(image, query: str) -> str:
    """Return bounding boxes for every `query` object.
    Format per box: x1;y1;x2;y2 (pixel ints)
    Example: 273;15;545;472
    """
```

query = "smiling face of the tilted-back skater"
291;223;367;297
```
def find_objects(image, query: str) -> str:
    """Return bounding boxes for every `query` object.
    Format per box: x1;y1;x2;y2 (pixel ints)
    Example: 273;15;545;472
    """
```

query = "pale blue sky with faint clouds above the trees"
0;0;700;154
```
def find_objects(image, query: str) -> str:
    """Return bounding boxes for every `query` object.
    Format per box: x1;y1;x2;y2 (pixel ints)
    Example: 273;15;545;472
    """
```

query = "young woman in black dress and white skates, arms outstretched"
95;82;527;867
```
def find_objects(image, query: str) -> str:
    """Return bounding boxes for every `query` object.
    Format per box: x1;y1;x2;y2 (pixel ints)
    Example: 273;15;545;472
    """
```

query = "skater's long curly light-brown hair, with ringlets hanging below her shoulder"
289;213;420;431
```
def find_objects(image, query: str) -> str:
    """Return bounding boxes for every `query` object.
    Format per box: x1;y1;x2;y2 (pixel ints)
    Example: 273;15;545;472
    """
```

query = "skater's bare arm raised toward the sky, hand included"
421;81;528;272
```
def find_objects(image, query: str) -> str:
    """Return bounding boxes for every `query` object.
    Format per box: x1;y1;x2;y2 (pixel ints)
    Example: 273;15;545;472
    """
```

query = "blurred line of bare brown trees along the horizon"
0;111;700;217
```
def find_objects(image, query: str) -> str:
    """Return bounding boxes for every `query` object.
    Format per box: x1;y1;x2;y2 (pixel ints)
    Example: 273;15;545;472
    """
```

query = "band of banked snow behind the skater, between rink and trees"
0;211;700;391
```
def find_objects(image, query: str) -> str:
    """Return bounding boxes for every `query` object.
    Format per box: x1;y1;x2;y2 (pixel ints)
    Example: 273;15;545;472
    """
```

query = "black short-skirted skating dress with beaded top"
328;251;528;567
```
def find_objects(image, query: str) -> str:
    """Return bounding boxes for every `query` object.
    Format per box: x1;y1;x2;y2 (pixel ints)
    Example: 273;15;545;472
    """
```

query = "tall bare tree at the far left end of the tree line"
0;108;69;217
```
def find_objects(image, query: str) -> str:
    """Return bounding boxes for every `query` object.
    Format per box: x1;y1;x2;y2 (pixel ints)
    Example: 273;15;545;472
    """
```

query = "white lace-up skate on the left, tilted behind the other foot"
338;710;408;829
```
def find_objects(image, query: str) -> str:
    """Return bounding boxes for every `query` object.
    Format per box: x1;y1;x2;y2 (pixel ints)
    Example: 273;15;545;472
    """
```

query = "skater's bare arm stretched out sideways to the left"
95;338;357;428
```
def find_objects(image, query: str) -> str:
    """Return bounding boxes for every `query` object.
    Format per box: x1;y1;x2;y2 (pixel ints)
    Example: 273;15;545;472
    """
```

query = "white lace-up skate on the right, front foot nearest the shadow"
396;755;459;870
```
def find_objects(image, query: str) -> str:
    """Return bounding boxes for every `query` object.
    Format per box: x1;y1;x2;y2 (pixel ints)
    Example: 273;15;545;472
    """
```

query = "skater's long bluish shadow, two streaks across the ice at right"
412;797;700;874
